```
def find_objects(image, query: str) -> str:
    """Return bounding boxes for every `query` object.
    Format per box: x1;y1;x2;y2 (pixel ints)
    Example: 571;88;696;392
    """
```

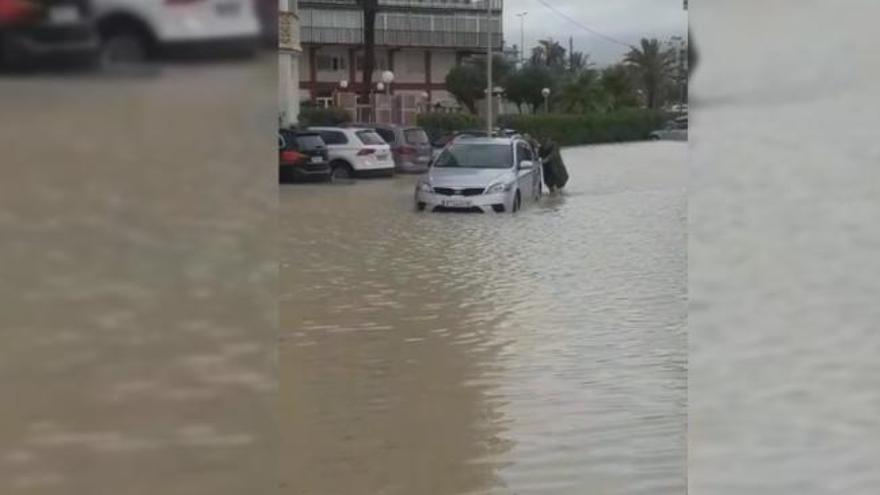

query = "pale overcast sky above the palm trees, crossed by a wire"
504;0;687;65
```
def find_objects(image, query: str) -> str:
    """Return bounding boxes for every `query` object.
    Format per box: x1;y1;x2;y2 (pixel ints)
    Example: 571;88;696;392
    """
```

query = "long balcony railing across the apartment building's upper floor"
302;26;503;49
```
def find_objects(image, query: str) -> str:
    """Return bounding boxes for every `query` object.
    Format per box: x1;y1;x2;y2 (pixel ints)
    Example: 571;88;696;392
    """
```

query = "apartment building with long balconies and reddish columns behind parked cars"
299;0;503;104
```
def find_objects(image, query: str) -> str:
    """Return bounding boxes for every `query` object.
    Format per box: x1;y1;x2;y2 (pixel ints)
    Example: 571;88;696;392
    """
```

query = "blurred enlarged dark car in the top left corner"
0;0;100;68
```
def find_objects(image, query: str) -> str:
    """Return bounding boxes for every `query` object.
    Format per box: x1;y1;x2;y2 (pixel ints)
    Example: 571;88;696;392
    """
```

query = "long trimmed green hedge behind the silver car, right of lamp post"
498;109;669;146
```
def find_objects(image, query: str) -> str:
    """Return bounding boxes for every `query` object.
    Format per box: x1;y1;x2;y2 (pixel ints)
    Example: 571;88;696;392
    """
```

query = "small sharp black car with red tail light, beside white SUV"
278;129;332;182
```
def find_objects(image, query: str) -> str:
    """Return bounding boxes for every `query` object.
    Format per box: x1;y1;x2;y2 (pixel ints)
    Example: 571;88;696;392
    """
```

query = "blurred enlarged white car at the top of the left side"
92;0;261;64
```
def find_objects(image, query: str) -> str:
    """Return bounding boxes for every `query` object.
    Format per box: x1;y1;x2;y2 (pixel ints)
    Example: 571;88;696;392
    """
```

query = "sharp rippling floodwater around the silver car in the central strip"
279;143;687;495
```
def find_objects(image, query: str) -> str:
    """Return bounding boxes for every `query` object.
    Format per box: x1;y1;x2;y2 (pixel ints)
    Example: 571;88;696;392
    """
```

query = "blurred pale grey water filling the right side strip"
689;0;880;495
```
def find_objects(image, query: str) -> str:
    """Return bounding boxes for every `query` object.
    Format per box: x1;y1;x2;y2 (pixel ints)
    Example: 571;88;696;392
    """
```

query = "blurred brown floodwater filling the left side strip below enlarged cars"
0;57;278;495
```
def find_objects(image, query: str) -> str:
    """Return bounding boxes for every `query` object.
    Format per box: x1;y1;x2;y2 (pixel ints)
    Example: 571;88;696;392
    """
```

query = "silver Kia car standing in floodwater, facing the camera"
415;137;543;213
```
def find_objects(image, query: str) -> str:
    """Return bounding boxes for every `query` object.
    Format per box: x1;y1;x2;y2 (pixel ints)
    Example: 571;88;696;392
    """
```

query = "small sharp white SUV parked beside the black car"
308;127;394;179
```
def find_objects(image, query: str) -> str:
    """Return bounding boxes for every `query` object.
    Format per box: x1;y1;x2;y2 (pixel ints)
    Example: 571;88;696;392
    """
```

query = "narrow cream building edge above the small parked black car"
278;0;302;127
